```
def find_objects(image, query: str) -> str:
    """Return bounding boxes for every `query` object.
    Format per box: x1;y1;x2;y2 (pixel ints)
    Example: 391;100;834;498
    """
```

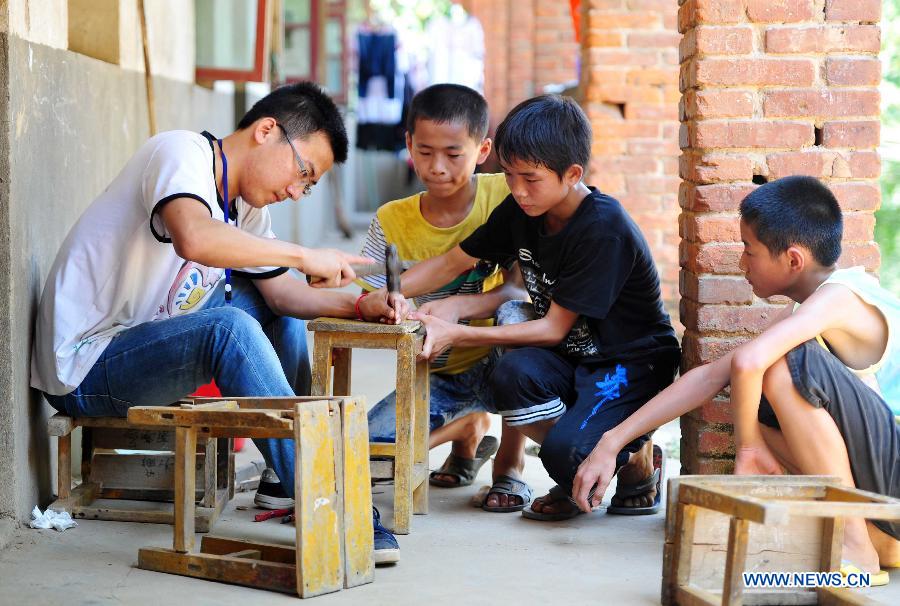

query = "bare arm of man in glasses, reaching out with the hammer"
160;198;368;287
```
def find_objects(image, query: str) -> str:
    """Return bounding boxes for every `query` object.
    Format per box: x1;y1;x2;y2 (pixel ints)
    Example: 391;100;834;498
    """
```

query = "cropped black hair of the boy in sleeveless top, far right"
740;176;844;267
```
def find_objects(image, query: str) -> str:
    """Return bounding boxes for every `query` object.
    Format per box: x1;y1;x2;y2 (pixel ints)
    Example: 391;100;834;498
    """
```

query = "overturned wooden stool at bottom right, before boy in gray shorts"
662;476;900;606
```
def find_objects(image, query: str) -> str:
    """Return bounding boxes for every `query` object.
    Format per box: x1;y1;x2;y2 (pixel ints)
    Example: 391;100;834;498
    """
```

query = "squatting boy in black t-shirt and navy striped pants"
362;95;679;520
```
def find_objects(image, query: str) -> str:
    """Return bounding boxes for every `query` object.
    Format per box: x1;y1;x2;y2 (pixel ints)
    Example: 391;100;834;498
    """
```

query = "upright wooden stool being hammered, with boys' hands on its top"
306;318;430;534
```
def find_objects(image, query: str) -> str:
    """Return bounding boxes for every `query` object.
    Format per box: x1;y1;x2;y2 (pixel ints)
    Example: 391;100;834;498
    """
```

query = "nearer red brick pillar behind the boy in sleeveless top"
678;0;881;473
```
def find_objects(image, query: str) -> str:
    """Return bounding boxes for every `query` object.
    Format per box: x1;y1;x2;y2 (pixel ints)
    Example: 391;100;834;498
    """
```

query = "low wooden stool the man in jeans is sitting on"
48;413;234;532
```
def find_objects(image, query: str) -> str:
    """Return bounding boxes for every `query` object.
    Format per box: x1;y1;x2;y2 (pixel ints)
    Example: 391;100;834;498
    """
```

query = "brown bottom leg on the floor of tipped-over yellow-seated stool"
138;547;296;593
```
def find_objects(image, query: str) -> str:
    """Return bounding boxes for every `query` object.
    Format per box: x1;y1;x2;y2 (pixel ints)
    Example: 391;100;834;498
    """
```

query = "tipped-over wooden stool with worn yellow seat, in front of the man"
128;397;375;598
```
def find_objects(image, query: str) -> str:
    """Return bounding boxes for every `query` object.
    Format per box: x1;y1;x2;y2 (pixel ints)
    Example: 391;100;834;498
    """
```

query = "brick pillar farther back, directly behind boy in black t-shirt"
580;0;681;311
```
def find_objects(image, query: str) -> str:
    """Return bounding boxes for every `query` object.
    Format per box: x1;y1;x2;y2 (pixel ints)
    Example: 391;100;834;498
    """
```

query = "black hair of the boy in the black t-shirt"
494;95;593;179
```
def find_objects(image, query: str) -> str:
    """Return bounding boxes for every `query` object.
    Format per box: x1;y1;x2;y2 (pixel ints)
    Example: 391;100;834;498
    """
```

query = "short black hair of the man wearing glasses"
238;82;348;164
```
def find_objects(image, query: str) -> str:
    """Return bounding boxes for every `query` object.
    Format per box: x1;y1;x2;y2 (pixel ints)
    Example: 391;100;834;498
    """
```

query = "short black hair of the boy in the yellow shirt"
406;84;488;143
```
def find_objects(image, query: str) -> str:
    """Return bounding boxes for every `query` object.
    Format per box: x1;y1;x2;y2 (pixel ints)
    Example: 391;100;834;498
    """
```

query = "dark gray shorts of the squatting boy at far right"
759;341;900;540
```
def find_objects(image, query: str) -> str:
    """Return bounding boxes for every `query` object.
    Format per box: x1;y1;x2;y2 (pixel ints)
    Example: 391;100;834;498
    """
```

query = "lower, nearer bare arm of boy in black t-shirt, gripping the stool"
410;302;578;359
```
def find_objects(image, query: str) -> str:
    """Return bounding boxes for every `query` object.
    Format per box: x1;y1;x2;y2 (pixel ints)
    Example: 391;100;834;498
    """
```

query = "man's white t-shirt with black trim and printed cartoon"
31;130;287;395
